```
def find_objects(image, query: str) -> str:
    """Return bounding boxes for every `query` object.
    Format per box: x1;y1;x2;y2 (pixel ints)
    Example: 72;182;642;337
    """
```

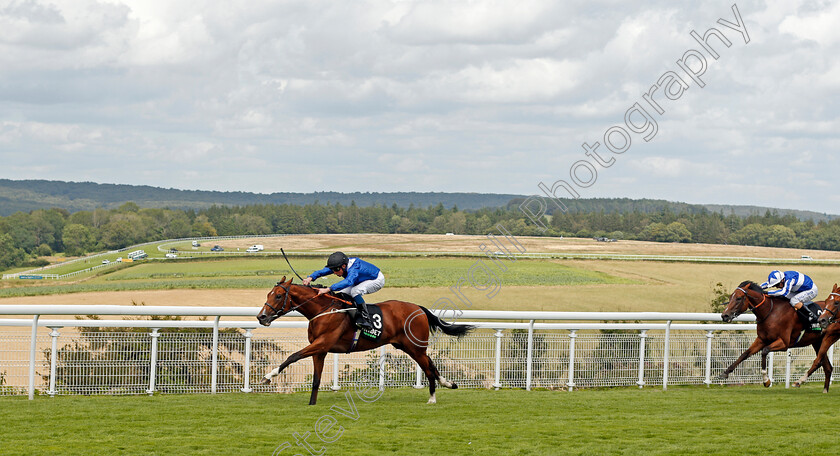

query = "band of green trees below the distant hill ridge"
0;201;840;269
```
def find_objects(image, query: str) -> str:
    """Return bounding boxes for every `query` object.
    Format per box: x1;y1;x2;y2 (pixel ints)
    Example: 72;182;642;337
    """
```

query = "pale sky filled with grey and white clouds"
0;0;840;214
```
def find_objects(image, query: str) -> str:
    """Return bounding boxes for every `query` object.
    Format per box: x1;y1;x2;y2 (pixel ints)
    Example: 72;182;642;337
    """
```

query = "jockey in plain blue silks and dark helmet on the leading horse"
303;252;385;330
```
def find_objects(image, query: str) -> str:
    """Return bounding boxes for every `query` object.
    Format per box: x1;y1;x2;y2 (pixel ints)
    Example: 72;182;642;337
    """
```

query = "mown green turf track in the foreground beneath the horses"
0;385;836;456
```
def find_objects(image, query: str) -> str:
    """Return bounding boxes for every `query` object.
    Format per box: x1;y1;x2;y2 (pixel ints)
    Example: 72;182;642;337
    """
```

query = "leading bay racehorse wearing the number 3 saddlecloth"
257;276;474;405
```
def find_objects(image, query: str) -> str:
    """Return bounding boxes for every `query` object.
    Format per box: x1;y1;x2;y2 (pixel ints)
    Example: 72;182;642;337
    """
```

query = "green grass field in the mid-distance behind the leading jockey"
0;257;636;297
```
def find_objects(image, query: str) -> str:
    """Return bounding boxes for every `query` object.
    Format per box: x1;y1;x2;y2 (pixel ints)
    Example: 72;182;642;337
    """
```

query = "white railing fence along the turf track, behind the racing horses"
0;305;833;399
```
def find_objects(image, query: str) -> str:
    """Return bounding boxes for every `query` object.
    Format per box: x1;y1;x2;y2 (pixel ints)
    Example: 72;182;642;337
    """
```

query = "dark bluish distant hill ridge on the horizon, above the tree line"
0;179;840;221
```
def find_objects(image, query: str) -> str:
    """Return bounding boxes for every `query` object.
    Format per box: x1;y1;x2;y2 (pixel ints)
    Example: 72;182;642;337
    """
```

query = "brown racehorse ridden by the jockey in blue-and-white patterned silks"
718;280;836;393
